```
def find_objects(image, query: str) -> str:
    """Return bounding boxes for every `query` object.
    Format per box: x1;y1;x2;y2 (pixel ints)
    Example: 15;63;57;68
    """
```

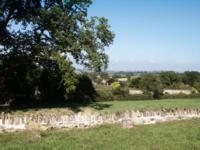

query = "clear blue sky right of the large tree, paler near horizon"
88;0;200;72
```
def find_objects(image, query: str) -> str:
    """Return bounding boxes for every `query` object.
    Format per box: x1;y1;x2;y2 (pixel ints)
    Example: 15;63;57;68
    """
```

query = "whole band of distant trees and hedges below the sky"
87;71;200;99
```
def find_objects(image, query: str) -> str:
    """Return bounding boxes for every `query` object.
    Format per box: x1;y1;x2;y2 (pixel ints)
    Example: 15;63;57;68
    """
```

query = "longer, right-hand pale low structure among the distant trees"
163;89;192;95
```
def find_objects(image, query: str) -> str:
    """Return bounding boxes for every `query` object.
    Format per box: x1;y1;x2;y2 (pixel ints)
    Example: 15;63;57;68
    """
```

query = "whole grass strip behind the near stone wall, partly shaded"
3;98;200;114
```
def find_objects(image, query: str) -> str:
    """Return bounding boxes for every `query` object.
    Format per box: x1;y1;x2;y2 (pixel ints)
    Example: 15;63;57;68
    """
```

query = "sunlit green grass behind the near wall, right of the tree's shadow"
91;99;200;112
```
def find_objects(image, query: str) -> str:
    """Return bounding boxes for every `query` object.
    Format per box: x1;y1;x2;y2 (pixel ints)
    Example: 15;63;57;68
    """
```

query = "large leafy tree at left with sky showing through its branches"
0;0;114;103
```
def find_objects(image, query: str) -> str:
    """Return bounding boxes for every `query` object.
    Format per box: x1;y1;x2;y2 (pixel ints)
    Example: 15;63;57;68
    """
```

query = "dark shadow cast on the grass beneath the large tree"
0;102;112;113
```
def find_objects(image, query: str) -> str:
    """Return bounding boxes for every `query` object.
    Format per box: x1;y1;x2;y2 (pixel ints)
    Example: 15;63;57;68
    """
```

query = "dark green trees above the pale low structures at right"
129;71;200;98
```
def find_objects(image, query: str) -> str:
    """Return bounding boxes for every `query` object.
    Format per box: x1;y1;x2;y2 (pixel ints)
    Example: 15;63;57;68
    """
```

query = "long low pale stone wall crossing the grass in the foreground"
0;109;200;132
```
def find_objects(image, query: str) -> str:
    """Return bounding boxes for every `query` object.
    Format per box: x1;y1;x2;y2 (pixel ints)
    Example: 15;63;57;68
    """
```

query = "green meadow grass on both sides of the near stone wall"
0;99;200;150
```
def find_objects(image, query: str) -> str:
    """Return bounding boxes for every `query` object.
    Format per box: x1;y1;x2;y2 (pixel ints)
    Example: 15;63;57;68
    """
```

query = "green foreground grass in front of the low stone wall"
0;119;200;150
